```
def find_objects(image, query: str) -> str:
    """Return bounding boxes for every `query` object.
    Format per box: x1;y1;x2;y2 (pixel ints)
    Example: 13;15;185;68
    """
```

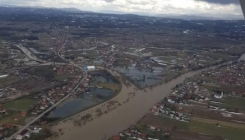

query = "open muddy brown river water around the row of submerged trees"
49;54;245;140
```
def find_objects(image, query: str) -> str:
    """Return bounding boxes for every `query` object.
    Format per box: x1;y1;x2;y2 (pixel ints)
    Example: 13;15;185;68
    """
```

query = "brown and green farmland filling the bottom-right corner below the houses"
138;114;245;140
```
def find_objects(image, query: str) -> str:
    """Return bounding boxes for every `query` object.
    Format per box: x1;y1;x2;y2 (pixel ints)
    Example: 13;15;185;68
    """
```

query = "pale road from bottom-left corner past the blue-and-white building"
7;37;87;140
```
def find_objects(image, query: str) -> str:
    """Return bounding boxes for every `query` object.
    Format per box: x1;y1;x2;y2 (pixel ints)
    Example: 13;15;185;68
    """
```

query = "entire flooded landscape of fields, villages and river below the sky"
0;7;245;140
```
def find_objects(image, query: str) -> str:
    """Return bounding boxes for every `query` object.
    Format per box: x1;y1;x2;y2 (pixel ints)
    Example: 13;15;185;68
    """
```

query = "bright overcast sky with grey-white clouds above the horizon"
0;0;242;15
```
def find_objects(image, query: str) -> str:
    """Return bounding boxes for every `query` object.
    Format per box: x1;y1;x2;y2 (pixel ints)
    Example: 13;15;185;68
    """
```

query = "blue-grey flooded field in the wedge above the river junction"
114;66;165;88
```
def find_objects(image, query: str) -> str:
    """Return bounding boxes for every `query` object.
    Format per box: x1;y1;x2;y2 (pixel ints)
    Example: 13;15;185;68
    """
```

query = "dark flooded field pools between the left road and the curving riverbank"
48;71;118;118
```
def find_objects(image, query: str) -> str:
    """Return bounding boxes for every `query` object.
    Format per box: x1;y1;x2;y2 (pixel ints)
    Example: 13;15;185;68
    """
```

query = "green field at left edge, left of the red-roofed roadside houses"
3;98;37;111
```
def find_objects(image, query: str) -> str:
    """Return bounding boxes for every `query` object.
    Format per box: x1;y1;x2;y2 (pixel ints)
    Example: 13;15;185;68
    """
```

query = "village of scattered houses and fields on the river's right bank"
112;60;245;140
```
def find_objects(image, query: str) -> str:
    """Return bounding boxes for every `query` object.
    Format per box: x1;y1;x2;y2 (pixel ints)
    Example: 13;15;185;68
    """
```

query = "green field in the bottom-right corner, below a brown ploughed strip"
189;121;245;140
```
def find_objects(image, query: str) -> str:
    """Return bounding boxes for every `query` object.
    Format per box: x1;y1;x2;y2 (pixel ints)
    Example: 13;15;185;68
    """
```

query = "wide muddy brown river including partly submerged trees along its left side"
48;55;245;140
